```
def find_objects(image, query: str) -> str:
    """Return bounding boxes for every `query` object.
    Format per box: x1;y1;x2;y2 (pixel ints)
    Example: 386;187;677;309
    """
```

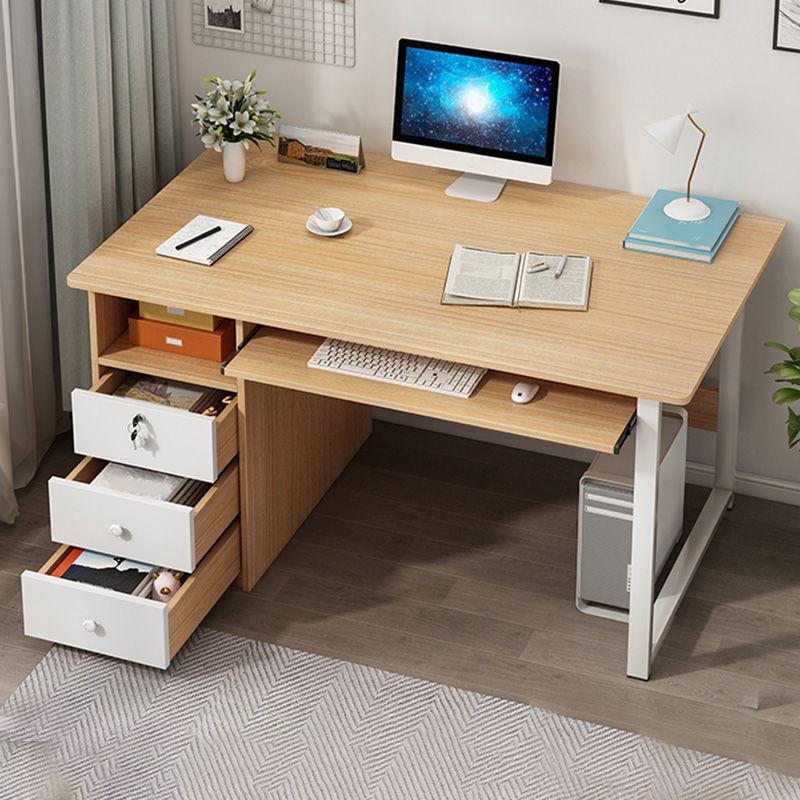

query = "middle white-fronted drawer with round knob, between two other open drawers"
48;458;239;572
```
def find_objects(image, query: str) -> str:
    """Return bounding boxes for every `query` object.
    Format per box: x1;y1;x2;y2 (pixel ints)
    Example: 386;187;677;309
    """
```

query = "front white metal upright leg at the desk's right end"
628;400;661;680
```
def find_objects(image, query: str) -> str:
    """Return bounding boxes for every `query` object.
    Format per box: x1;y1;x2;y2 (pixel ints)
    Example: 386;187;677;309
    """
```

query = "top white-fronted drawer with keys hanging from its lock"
72;370;238;483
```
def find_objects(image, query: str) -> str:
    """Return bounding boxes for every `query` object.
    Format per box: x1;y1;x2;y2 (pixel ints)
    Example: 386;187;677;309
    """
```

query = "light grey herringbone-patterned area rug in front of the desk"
0;629;800;800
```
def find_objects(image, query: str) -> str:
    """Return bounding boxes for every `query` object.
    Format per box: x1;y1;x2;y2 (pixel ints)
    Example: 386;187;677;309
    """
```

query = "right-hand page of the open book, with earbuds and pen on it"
518;253;591;309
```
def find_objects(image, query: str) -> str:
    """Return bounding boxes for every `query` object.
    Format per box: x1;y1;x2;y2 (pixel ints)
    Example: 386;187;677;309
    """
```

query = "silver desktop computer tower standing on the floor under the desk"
576;407;688;621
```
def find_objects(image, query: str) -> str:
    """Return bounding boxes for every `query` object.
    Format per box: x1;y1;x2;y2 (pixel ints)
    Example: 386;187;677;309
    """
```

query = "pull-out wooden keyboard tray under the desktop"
225;328;636;453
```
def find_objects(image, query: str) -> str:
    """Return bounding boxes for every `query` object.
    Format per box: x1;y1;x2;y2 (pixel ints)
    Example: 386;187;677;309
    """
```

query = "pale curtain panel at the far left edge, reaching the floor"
0;0;58;522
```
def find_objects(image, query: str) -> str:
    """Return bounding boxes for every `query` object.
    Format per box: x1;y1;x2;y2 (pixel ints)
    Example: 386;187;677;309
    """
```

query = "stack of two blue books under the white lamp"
622;189;739;264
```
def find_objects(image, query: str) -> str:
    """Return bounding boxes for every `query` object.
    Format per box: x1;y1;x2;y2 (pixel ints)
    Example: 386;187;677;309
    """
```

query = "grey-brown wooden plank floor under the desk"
0;423;800;776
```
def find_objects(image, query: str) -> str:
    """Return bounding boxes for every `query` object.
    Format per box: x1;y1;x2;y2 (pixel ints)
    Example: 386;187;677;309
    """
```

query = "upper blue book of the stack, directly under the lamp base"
628;189;739;253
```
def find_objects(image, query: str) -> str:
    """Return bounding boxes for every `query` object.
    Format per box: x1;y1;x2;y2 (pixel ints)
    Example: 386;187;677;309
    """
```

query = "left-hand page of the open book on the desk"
445;245;519;305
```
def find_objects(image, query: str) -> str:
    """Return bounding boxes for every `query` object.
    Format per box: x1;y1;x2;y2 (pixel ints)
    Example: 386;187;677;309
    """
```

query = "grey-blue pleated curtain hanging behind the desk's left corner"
41;0;181;407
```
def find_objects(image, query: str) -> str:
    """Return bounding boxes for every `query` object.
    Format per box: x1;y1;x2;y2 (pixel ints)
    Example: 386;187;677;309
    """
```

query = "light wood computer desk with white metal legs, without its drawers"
68;148;784;679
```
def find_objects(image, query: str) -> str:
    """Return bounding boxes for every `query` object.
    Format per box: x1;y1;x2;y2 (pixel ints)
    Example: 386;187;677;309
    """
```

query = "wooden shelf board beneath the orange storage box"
98;331;236;391
